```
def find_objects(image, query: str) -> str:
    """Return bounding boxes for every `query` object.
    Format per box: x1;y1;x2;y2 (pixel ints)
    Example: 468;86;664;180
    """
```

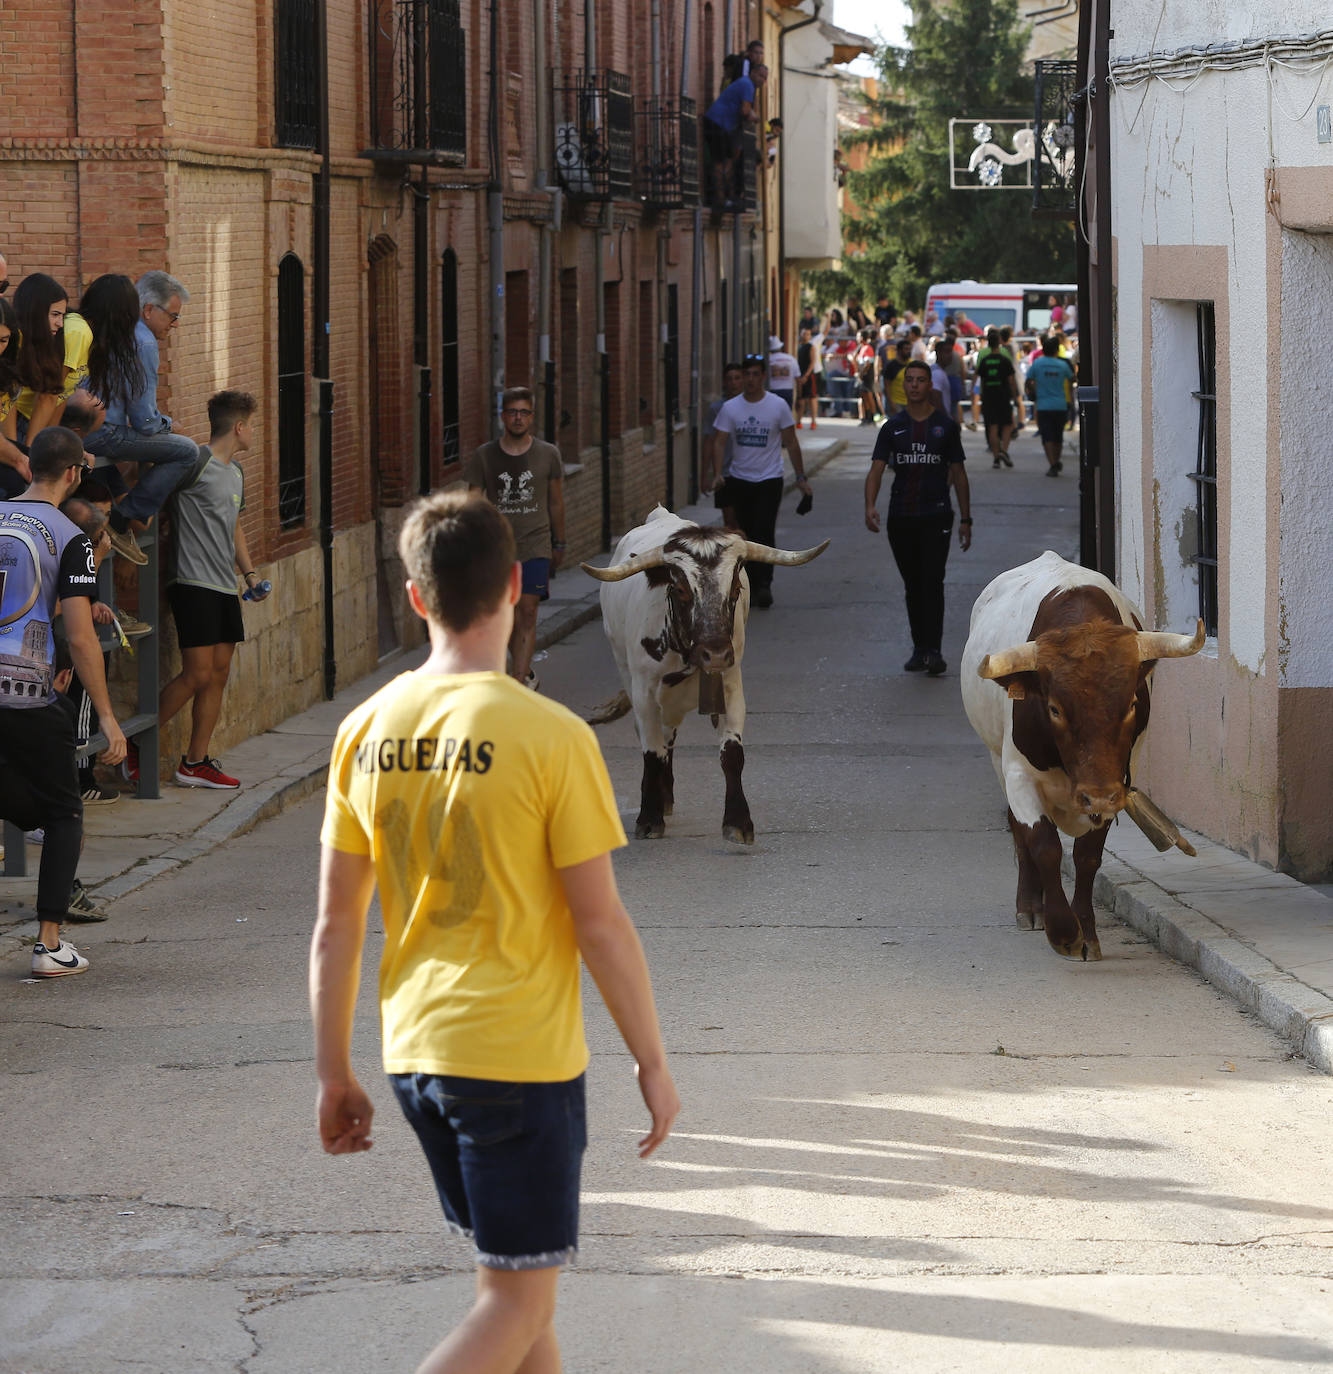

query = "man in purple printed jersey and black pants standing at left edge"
0;425;125;978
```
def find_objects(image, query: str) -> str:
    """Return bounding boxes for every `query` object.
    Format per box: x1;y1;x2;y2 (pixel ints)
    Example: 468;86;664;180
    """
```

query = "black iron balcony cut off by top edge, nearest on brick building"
363;0;467;166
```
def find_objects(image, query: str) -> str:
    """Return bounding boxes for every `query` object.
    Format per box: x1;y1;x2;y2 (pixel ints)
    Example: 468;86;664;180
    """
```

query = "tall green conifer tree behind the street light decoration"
807;0;1075;308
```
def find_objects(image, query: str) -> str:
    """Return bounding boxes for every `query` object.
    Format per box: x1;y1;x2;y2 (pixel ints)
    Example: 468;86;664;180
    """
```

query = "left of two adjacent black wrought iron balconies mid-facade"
551;69;634;201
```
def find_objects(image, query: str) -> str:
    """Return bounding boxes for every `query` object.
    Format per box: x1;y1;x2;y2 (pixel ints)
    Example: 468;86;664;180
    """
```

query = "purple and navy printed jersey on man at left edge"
0;502;98;710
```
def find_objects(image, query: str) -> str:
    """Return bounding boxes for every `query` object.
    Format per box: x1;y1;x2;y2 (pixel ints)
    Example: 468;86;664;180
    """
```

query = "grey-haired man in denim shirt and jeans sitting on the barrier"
88;272;199;563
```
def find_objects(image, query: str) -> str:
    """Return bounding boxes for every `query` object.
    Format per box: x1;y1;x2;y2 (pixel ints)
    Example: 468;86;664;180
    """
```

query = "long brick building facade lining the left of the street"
0;0;772;747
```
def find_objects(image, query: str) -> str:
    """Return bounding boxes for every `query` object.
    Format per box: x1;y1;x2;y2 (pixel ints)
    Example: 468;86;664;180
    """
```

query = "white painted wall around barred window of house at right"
1112;0;1333;673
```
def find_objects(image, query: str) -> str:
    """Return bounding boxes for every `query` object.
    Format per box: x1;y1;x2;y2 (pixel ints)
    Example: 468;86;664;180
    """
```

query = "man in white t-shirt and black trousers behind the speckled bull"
713;353;814;606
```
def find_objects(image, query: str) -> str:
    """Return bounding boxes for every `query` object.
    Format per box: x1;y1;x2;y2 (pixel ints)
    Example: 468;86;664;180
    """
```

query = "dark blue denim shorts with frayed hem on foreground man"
389;1073;588;1270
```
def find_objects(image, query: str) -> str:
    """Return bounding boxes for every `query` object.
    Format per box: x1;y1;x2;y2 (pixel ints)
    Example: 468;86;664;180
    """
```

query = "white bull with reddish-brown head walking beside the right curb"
962;552;1204;959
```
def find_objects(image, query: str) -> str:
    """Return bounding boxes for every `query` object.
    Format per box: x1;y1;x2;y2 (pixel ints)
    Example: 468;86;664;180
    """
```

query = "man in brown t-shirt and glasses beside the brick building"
463;386;565;691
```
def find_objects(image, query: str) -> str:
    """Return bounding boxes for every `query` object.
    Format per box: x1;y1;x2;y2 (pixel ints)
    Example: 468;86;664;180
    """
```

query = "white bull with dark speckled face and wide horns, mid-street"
581;506;829;845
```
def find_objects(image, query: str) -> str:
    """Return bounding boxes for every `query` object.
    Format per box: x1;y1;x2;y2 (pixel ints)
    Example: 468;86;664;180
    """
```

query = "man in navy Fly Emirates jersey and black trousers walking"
866;361;972;677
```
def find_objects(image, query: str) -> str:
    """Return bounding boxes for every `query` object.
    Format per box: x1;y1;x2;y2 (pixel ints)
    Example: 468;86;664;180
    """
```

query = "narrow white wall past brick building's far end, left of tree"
781;23;842;261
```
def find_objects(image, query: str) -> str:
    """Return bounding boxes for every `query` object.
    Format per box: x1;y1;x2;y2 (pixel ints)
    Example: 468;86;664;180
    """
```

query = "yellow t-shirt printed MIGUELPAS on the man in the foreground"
320;673;625;1083
